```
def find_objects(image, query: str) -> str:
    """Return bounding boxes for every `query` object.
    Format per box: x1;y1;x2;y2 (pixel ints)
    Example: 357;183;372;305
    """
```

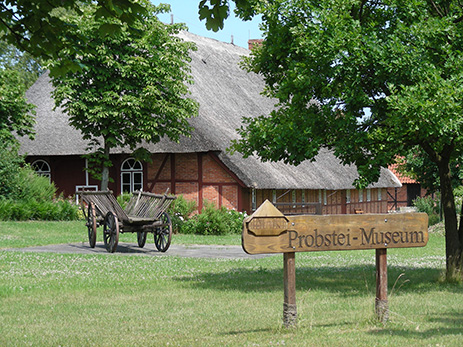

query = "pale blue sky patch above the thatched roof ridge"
151;0;262;48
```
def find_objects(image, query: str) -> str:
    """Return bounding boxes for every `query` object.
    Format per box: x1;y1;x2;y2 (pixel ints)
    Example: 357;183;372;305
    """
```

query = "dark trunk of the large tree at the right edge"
438;160;463;277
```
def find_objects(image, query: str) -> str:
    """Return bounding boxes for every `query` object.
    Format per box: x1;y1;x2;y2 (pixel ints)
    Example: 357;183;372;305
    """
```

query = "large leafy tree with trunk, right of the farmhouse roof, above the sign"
221;0;463;275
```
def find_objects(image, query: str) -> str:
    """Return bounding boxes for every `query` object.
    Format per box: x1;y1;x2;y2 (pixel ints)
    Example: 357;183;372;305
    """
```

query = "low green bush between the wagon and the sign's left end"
180;203;244;235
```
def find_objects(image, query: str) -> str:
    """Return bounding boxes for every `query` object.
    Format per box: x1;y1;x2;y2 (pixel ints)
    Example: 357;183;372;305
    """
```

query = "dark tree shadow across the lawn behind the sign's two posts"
174;265;454;297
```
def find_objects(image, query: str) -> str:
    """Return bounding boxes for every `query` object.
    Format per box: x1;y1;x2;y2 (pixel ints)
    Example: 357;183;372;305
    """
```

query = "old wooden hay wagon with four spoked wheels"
79;191;176;253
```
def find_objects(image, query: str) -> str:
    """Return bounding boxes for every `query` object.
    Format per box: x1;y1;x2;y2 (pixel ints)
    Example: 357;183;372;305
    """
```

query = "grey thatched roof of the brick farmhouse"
20;32;400;189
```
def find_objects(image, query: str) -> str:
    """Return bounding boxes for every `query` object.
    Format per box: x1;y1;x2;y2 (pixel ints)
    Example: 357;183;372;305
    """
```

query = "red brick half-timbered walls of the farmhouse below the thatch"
28;153;388;214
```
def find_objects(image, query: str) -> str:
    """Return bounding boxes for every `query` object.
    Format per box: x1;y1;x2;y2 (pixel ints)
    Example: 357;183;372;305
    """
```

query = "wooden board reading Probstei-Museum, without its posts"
242;200;428;254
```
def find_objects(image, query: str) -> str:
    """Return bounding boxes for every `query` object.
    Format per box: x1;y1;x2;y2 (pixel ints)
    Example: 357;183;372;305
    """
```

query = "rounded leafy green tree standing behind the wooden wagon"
52;3;198;190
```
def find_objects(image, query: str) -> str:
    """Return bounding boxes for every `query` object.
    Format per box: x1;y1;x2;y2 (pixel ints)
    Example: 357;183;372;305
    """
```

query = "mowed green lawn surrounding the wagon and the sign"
0;222;463;346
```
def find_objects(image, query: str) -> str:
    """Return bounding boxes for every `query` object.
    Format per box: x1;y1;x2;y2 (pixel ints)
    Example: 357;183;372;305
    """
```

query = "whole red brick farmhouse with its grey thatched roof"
20;32;400;213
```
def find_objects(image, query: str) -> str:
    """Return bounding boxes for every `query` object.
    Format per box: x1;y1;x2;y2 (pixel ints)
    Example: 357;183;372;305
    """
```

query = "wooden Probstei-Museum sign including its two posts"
242;200;428;326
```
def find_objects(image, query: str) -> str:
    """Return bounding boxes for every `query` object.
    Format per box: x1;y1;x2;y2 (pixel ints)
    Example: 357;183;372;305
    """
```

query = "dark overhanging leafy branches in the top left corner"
0;0;145;74
